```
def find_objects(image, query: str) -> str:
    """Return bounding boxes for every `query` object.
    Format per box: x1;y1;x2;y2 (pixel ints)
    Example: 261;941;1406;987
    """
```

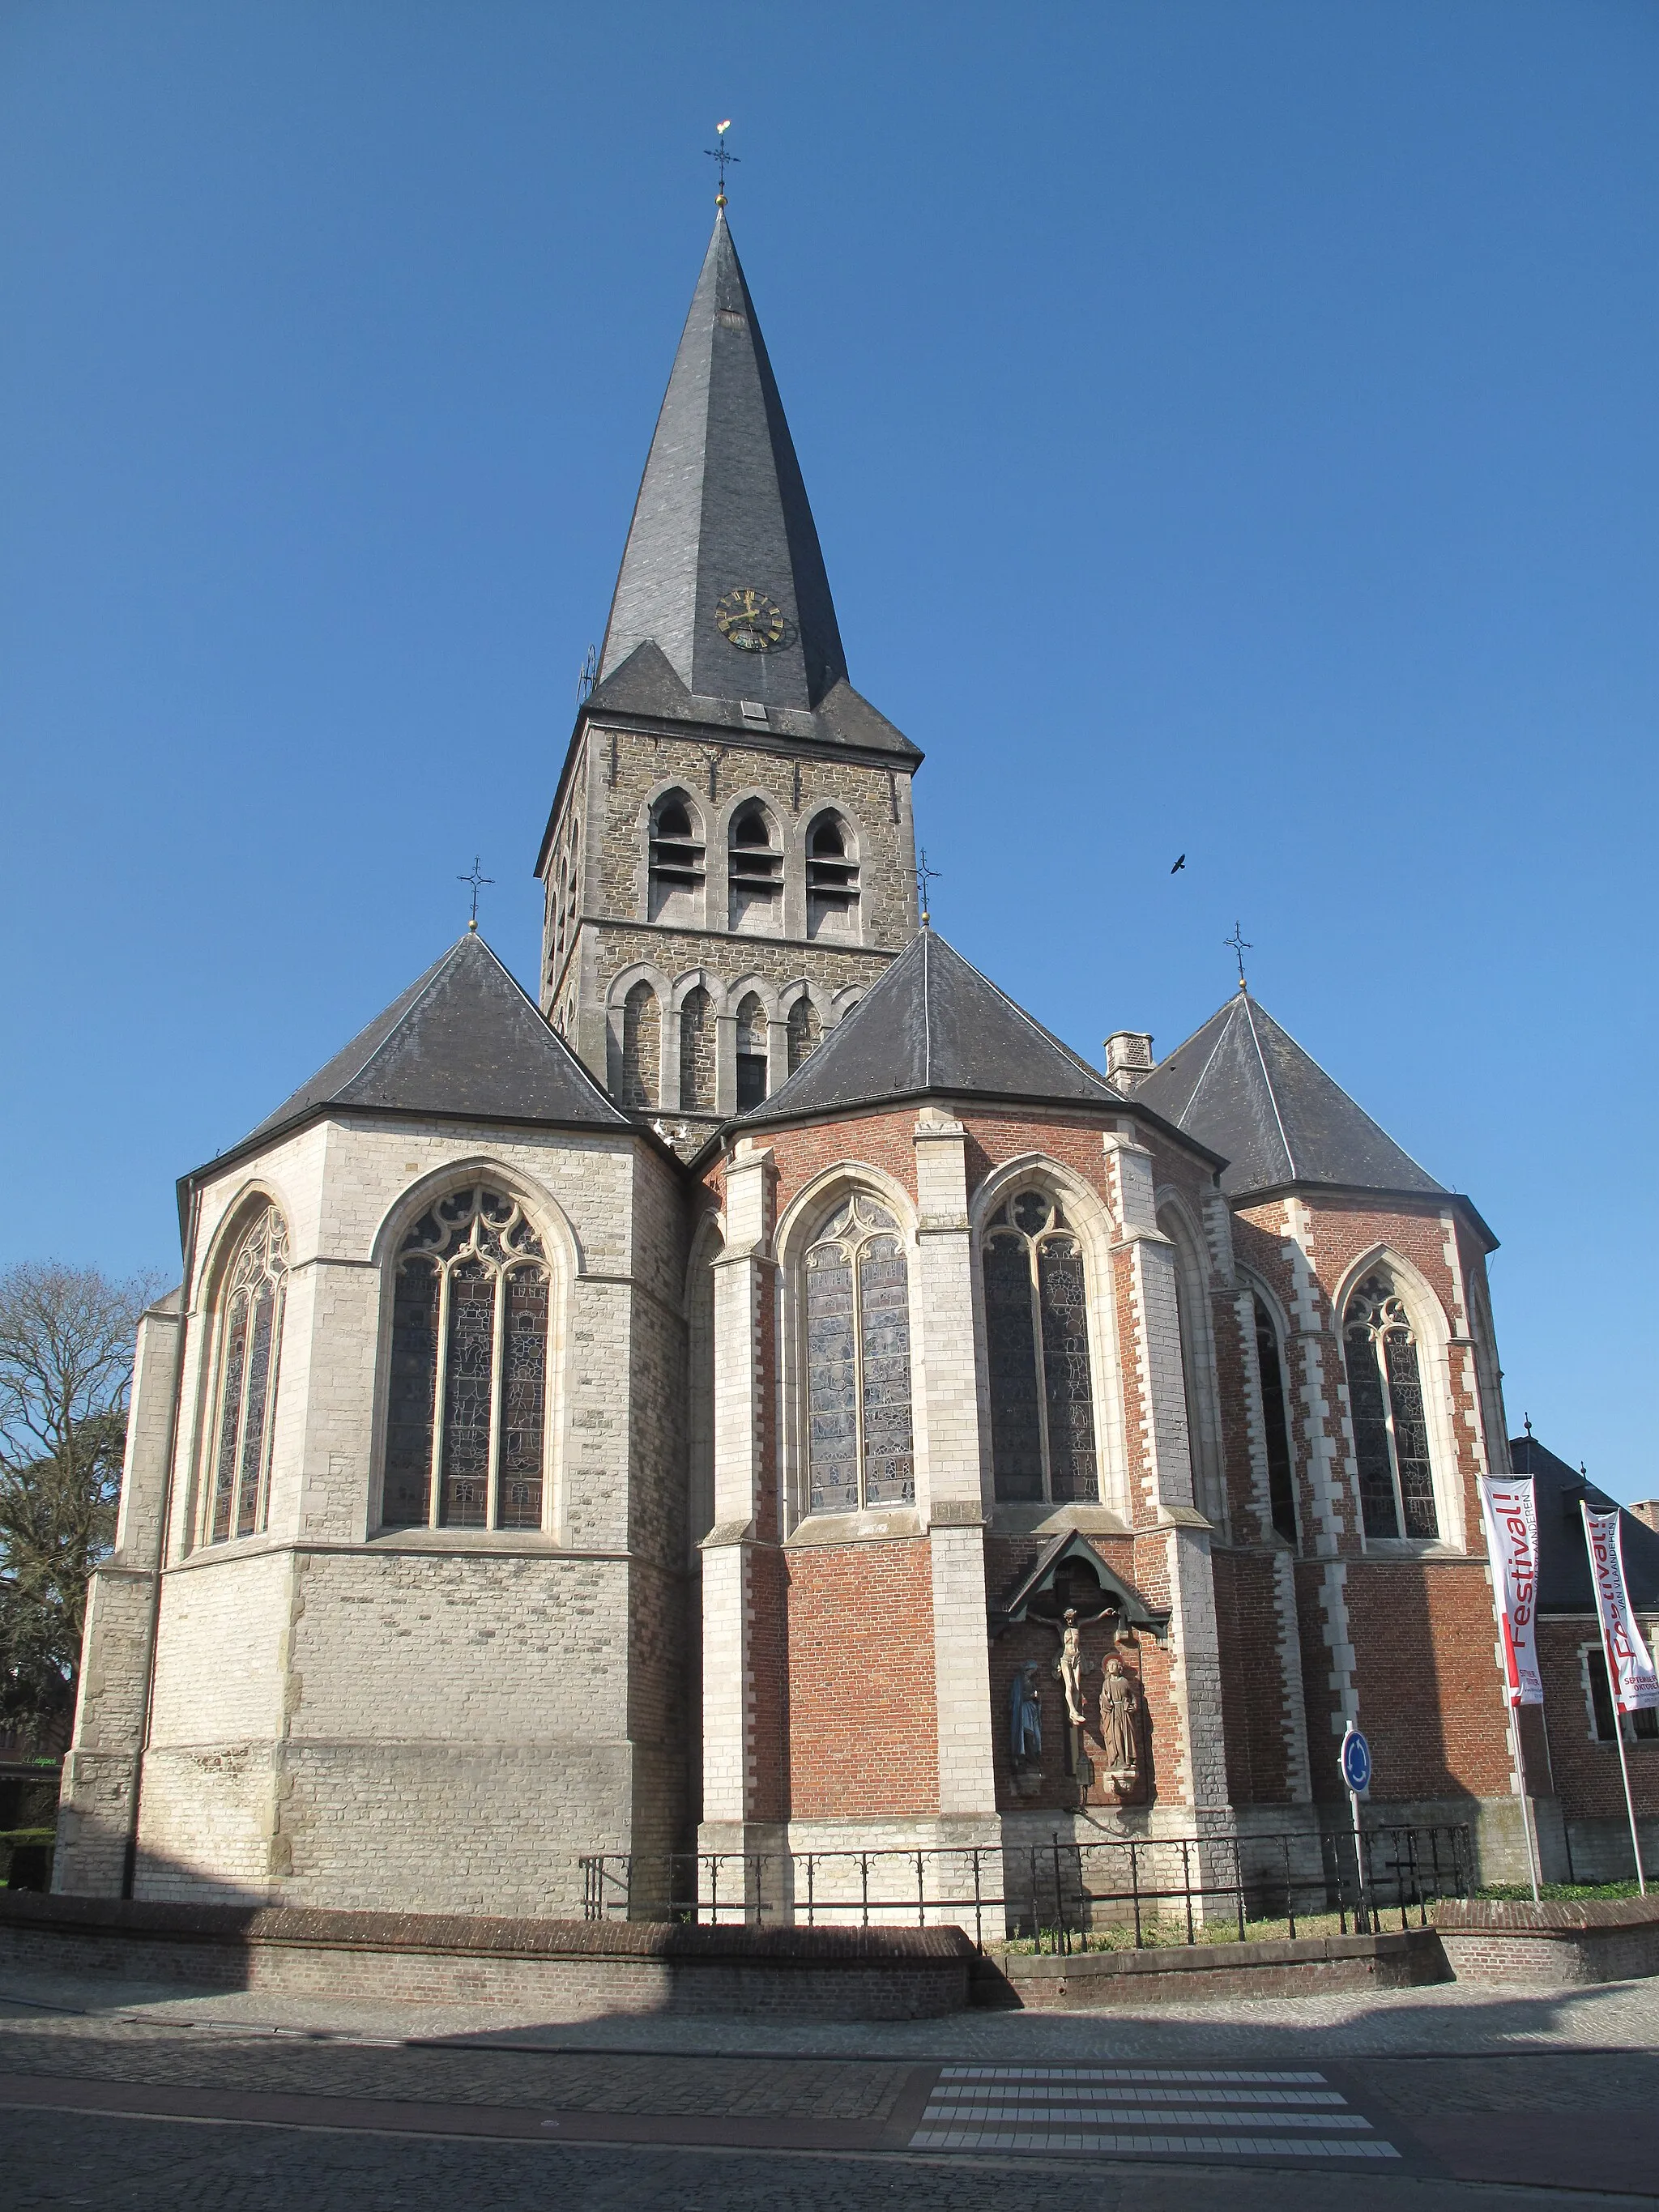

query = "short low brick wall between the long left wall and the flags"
973;1929;1451;2010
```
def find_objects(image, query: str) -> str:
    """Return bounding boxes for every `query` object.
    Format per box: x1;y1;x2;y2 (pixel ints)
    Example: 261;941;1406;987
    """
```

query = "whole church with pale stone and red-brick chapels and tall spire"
55;208;1601;1913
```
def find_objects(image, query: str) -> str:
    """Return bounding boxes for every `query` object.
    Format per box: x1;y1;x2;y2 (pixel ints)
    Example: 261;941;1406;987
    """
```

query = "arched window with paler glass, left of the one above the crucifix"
805;1192;915;1513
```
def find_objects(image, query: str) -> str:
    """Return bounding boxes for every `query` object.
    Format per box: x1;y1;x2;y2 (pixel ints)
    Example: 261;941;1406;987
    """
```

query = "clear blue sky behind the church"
0;0;1659;1498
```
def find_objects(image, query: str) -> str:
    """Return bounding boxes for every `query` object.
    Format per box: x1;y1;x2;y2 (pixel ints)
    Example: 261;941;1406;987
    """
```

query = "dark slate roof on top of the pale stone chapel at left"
243;929;633;1144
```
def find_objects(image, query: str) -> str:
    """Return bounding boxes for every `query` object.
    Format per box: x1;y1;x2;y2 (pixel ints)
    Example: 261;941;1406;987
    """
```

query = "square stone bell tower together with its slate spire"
535;208;923;1153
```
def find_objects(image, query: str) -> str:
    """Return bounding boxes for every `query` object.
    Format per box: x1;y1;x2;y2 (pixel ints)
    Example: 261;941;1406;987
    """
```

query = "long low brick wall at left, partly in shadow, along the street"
0;1891;975;2019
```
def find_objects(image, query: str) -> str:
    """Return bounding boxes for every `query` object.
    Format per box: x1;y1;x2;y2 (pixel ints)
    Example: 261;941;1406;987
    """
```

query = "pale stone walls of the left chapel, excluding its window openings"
60;1115;688;1913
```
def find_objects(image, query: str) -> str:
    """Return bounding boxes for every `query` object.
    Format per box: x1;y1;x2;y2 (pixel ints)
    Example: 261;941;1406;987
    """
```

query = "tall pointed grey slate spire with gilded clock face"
599;208;847;708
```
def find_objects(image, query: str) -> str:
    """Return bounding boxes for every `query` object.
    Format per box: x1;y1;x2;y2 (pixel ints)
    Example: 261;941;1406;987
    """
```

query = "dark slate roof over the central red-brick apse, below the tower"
736;929;1126;1128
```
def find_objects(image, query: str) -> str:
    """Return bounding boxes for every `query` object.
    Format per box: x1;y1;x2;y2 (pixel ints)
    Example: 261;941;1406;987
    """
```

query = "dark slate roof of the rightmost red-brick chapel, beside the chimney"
1135;991;1444;1199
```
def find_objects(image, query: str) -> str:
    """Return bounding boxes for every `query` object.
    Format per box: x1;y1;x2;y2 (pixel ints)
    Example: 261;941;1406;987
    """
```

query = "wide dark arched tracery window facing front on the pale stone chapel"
381;1188;548;1528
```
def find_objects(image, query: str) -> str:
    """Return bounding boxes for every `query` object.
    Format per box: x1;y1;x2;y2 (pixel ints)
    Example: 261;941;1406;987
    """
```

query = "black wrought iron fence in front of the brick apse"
582;1825;1475;1951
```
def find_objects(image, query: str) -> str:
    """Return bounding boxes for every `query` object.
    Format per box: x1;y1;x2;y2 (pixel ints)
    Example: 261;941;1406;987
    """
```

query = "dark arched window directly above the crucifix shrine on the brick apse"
984;1190;1099;1500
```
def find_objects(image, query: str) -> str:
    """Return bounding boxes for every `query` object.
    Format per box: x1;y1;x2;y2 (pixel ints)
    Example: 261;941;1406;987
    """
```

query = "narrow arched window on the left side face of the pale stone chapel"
208;1201;288;1544
